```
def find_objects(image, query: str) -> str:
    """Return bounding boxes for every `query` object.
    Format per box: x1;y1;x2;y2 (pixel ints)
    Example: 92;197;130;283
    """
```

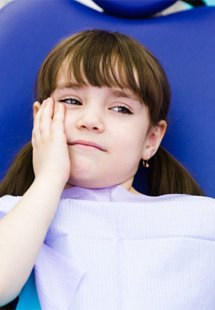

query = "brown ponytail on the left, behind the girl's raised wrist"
0;143;34;197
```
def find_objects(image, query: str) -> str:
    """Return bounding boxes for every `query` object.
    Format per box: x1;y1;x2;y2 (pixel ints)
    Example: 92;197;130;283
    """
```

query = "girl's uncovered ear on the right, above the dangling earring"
142;120;167;160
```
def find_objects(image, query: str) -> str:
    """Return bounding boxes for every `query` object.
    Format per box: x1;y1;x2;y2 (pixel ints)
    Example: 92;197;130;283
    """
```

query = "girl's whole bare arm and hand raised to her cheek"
0;98;70;306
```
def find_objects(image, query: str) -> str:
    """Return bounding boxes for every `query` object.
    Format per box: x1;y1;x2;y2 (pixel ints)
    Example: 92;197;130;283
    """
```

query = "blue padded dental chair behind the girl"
0;0;215;310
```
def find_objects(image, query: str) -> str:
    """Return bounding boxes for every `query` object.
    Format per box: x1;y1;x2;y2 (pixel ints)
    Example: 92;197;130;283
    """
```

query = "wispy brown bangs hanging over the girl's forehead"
56;30;141;97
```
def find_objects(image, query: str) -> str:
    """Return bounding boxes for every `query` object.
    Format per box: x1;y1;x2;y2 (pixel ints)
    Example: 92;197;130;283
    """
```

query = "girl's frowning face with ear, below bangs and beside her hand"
52;72;166;190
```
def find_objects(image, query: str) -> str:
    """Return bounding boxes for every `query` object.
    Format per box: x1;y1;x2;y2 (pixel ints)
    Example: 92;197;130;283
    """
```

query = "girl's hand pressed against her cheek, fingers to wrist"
32;97;70;187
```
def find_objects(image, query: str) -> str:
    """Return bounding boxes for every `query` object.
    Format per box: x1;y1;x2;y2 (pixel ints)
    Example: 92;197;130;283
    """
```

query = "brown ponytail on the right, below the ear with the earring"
149;147;204;196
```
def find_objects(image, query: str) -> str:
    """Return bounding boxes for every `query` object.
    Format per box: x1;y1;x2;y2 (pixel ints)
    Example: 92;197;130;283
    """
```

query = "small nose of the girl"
76;109;104;133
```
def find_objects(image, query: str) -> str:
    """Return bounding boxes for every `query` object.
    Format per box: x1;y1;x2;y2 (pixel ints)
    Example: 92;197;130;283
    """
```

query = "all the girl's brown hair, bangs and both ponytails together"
0;30;203;195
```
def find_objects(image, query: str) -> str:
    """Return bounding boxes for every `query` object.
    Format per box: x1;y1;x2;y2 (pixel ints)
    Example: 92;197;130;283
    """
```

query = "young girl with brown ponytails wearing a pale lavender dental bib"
0;30;215;310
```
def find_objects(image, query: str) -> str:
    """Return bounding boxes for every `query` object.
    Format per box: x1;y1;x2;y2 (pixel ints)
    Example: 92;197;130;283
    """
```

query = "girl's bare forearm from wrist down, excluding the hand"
0;178;63;305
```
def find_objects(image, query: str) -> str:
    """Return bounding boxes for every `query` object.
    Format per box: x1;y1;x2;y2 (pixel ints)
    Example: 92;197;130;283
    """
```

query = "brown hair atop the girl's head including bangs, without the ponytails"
36;30;170;124
